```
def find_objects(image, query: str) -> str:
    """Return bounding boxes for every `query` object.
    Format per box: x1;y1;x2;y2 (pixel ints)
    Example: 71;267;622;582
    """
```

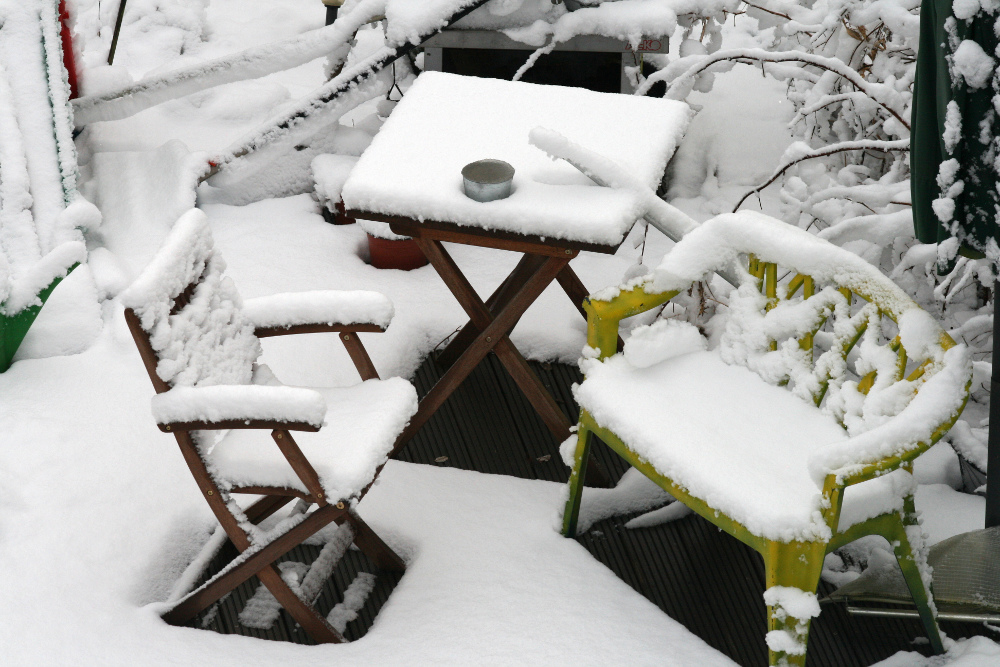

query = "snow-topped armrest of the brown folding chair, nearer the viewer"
152;385;326;432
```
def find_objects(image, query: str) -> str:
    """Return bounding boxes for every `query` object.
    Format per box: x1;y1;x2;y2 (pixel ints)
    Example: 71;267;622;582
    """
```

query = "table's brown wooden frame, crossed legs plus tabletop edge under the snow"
347;210;622;487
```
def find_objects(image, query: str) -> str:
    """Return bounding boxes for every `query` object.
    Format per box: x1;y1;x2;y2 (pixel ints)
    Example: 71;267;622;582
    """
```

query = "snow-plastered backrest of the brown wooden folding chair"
121;209;261;392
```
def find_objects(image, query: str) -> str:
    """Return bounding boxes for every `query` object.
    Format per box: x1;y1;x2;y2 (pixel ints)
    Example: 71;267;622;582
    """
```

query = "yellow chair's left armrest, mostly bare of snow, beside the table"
583;279;682;359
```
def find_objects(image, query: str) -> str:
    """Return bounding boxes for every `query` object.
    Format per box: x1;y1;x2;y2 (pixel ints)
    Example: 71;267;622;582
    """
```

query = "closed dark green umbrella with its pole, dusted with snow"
910;0;1000;527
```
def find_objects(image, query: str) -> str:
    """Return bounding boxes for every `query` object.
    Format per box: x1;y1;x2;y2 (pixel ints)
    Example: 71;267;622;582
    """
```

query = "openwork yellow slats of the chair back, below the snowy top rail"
720;258;940;435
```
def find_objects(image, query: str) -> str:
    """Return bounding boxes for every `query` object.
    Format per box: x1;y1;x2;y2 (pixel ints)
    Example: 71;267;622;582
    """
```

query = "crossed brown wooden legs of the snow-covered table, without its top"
393;237;609;486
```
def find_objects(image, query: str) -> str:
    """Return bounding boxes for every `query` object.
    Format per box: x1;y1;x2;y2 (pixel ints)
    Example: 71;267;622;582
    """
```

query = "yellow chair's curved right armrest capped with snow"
808;345;972;486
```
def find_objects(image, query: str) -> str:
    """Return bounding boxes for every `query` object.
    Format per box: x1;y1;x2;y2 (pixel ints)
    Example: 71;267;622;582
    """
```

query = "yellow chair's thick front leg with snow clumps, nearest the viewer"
764;542;826;667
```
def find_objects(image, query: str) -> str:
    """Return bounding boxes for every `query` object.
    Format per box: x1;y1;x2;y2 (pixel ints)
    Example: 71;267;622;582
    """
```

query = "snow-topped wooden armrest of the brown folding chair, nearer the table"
243;290;394;338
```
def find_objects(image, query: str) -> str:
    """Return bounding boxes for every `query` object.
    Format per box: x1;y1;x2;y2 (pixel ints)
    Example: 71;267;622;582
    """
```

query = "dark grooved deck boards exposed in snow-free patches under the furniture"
193;354;987;667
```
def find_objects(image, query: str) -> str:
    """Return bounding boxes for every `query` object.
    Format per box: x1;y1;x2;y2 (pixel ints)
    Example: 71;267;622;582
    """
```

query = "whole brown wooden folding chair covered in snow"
121;210;417;642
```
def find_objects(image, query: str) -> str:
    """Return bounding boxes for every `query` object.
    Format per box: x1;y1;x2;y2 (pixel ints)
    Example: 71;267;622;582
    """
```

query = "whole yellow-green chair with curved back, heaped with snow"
563;213;971;665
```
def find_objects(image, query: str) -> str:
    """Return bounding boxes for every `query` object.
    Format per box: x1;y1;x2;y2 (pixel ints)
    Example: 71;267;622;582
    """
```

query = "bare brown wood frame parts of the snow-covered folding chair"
125;280;406;643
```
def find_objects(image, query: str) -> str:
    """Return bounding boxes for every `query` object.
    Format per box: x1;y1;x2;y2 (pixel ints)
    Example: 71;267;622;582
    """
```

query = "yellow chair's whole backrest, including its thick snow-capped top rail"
654;213;961;436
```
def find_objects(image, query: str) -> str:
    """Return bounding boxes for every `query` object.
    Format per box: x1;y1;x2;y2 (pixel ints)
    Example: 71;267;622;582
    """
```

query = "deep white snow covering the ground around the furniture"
0;0;1000;667
